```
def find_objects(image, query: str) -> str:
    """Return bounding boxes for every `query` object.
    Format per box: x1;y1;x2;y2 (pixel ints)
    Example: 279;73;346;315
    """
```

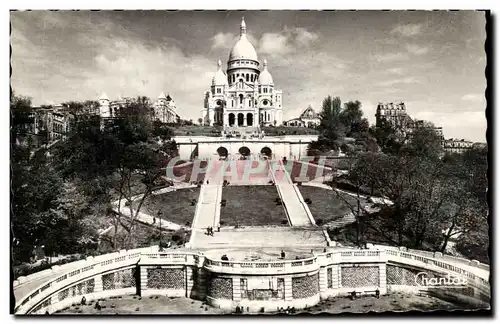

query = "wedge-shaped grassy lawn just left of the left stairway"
134;188;200;225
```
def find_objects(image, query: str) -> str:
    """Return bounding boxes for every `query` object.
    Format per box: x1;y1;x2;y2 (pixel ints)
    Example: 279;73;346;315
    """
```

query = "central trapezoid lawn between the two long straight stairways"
220;185;288;226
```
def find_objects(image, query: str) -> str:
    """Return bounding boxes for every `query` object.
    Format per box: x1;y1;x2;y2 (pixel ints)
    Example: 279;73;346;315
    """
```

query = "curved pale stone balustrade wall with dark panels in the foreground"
15;246;490;314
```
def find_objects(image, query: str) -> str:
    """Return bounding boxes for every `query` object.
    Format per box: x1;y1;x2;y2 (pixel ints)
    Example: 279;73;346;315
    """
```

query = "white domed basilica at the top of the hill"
202;19;283;128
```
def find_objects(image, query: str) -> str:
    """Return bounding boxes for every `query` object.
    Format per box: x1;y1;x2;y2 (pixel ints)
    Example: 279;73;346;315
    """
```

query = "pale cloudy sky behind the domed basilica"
10;11;486;142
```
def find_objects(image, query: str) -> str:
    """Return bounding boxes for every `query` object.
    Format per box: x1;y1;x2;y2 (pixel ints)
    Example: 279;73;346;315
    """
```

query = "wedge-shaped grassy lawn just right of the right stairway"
299;186;366;224
